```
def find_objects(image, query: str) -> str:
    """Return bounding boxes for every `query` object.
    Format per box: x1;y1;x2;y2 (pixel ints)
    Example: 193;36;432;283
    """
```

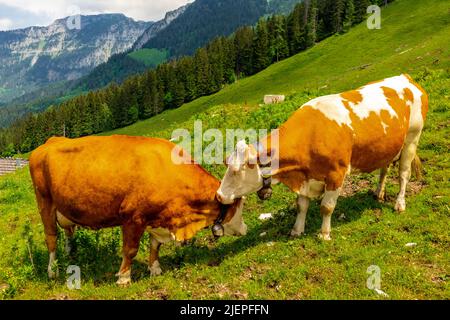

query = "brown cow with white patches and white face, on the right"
217;75;428;240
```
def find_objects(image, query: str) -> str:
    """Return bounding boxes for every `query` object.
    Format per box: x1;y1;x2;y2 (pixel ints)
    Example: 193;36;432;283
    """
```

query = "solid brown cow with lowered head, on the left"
30;136;247;285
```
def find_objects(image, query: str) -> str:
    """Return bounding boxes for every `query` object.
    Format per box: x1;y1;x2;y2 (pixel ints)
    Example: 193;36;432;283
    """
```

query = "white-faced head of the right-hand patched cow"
217;141;271;204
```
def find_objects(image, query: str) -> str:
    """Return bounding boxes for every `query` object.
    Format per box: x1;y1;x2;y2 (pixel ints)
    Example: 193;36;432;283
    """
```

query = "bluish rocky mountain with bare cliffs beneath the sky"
0;14;152;102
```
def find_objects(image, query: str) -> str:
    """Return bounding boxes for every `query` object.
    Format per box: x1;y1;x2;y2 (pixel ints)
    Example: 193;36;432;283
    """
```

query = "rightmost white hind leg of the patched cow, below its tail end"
395;138;420;212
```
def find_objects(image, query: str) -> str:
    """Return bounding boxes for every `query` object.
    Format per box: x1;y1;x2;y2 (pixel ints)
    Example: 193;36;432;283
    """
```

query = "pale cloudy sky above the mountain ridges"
0;0;192;31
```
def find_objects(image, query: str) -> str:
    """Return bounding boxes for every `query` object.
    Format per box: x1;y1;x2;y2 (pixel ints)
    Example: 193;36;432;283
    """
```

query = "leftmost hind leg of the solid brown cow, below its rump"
36;190;58;279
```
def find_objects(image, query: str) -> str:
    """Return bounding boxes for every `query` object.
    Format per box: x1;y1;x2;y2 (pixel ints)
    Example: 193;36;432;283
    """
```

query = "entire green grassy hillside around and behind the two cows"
0;0;450;299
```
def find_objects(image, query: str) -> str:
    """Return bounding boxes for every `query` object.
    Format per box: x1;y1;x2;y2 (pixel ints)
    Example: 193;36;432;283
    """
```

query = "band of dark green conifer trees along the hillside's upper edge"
0;0;391;156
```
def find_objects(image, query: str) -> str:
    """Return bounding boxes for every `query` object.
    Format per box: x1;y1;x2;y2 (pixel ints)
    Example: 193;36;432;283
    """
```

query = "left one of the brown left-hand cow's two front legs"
117;222;145;286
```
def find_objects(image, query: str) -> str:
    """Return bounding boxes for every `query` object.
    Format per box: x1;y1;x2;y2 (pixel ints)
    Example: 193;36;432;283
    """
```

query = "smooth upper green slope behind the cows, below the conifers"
105;0;450;135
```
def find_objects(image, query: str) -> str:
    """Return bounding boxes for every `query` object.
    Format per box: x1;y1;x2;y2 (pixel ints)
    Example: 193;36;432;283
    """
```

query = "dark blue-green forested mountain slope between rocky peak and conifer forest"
0;0;301;127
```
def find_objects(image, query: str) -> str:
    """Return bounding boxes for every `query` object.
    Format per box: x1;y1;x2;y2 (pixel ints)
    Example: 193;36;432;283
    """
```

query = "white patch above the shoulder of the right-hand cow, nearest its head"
303;94;352;128
